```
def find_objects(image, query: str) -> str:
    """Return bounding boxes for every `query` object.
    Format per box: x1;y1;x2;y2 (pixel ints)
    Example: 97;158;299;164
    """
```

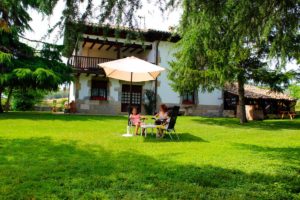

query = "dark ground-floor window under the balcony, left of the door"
91;80;107;101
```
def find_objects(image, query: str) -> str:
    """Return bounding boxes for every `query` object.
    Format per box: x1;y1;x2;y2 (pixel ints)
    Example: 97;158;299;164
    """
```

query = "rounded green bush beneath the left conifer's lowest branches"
12;89;45;111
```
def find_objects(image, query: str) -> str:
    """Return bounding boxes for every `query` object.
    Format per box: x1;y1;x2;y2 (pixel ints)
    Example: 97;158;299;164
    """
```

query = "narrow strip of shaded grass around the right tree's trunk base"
192;117;300;130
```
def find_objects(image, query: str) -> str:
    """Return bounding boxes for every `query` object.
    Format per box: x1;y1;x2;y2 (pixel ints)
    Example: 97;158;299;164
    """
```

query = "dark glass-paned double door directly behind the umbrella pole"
121;84;142;112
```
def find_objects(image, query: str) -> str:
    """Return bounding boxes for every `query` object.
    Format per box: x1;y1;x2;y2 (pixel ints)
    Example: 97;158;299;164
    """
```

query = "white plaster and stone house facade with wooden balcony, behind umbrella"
68;25;223;116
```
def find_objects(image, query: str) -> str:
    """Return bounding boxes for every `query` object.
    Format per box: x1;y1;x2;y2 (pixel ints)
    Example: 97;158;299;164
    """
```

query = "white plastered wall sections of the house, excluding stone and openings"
75;36;223;108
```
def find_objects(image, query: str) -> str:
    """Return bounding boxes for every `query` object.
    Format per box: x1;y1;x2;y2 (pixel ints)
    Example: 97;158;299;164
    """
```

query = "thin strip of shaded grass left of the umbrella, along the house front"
0;112;127;123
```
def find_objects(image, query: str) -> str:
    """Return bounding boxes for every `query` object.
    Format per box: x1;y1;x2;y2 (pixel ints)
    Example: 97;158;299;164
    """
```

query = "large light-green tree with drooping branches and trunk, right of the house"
169;0;300;123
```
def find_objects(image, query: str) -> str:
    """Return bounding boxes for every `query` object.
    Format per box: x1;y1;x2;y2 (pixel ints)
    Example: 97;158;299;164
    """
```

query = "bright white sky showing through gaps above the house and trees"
23;0;299;70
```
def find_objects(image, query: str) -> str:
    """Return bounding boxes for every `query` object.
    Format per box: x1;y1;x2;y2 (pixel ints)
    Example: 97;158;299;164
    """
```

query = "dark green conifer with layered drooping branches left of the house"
0;0;71;113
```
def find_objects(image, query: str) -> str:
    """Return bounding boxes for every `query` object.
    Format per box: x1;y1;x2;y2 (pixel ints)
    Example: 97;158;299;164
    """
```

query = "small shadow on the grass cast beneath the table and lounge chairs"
144;133;208;142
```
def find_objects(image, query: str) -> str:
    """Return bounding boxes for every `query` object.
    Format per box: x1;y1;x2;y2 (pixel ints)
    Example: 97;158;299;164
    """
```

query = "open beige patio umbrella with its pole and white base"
99;56;165;136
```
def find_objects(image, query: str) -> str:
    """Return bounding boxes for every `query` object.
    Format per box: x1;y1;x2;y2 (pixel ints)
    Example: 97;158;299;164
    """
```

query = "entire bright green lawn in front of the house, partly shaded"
0;113;300;199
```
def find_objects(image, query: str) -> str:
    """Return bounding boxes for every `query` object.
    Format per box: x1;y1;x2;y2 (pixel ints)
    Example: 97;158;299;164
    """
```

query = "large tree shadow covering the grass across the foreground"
0;138;300;199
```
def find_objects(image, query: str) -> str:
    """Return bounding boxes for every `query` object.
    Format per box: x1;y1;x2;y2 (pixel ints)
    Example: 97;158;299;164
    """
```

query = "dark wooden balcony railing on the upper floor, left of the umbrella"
69;56;114;75
